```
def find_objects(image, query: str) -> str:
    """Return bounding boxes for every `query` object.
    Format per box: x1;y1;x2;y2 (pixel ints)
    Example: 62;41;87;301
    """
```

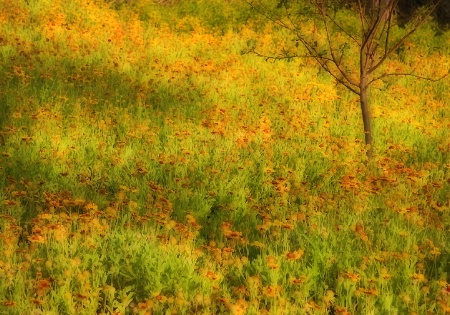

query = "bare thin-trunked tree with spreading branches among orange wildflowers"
247;0;442;159
